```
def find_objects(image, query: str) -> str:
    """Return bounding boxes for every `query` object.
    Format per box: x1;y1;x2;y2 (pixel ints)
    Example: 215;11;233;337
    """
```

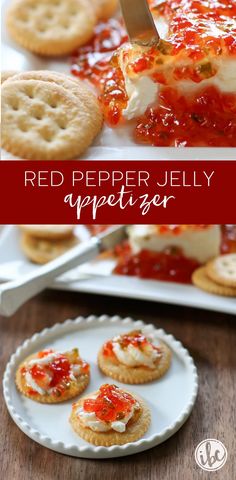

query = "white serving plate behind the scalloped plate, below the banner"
0;225;236;315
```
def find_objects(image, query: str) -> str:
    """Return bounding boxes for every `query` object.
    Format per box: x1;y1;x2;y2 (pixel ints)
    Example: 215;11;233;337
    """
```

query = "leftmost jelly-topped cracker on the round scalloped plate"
16;348;90;403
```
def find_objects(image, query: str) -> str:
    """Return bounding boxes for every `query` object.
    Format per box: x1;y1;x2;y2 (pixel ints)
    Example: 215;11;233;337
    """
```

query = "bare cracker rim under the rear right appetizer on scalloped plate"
98;342;172;385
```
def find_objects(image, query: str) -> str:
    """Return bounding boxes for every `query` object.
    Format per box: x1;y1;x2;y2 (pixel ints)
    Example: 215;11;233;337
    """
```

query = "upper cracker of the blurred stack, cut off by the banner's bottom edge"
19;225;74;240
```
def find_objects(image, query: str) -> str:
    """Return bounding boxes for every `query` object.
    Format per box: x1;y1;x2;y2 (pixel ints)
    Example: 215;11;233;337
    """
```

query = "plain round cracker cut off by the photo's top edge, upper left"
7;0;96;56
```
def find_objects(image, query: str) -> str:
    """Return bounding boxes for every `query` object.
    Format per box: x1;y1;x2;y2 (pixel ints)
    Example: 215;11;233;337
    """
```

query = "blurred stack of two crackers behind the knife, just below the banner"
19;225;78;264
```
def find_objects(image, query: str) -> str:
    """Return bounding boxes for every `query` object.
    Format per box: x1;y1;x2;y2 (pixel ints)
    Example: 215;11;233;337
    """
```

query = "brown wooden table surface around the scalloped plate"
0;291;236;480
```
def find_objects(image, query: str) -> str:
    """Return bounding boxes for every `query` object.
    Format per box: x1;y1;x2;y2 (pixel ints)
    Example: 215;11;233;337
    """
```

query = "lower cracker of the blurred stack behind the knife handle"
21;233;78;265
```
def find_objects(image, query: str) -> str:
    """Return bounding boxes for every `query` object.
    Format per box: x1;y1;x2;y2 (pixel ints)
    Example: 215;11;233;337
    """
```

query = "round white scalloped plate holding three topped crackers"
3;315;198;459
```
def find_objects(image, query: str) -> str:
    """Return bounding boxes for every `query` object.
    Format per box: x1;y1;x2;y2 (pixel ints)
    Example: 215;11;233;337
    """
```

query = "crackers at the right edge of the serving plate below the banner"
192;253;236;297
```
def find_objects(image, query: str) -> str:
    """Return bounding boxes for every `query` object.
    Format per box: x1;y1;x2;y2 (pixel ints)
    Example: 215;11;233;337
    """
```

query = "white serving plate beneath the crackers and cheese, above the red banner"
1;0;236;160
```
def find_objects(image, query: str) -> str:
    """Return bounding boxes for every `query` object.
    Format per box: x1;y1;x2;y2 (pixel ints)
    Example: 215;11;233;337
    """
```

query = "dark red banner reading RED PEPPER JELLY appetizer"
0;161;236;224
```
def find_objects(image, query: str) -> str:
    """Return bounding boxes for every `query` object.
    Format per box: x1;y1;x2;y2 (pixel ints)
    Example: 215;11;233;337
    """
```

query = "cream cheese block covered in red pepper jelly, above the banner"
72;0;236;147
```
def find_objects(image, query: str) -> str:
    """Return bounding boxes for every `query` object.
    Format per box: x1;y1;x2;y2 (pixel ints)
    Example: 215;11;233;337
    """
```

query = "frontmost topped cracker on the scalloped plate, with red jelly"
70;384;151;447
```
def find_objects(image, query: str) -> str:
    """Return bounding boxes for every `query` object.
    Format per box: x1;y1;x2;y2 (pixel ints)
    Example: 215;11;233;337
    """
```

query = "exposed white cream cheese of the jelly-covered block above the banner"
118;7;236;120
